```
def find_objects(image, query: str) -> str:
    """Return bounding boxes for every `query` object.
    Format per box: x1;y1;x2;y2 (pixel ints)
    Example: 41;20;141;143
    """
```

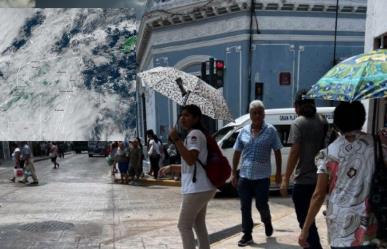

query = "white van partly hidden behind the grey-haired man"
214;107;335;190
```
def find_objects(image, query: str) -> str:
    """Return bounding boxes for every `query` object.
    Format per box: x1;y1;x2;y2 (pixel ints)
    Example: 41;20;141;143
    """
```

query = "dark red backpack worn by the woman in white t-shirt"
192;135;231;188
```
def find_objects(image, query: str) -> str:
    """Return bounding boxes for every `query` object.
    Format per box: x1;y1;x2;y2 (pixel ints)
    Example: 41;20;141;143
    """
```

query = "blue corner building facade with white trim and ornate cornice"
137;0;367;138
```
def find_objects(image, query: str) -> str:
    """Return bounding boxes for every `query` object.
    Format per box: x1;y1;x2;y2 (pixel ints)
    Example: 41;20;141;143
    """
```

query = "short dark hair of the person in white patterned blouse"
333;101;366;133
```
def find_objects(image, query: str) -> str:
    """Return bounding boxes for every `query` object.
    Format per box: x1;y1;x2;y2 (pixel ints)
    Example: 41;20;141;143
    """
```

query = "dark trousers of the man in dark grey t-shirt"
292;184;322;249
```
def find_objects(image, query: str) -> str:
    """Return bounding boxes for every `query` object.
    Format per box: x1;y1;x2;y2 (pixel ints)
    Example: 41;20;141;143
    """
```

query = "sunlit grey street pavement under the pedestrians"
0;154;326;249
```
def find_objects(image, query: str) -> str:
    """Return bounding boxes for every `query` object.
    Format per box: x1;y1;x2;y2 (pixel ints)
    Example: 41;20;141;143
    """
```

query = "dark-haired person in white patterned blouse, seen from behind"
298;101;377;249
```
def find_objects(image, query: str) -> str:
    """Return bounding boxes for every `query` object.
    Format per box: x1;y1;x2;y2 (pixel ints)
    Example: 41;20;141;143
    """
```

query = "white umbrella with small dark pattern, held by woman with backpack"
137;67;234;121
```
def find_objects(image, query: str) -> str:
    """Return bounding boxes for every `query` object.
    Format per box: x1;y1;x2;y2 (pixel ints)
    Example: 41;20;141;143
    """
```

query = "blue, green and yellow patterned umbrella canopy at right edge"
307;49;387;102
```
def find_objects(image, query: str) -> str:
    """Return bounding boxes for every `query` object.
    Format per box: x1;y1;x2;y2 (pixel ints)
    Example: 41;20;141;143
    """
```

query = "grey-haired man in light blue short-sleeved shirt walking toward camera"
232;100;282;246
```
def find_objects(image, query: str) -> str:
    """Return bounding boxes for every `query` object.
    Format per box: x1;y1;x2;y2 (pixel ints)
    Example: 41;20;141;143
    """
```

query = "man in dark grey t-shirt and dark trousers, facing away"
280;90;328;249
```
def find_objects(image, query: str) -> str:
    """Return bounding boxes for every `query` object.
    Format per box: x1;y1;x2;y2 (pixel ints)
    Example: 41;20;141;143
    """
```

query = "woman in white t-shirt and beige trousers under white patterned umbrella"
160;105;216;249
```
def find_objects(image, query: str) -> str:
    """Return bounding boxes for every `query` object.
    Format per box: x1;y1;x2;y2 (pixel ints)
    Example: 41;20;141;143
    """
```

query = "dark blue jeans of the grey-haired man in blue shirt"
238;177;271;235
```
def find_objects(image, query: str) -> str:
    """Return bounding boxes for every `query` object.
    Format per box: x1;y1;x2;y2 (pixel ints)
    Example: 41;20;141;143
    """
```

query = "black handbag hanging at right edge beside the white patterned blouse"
369;136;387;241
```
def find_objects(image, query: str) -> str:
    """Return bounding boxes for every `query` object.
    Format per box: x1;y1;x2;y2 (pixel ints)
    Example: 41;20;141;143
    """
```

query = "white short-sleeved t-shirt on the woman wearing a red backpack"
181;130;216;194
